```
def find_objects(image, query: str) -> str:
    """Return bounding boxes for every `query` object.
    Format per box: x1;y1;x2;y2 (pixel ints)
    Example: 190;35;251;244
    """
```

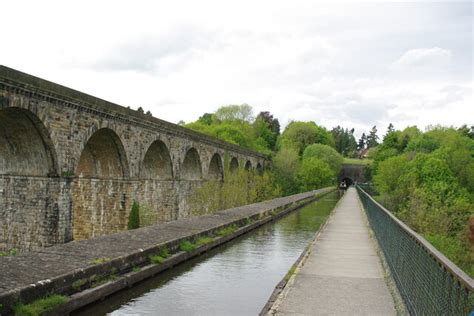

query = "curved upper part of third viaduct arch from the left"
140;140;173;180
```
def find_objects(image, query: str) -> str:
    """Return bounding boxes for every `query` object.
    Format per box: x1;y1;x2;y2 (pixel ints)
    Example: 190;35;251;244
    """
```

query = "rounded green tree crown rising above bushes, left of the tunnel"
278;122;334;155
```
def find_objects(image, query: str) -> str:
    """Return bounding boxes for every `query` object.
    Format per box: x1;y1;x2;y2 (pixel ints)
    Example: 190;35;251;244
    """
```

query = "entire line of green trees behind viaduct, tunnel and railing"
183;104;474;276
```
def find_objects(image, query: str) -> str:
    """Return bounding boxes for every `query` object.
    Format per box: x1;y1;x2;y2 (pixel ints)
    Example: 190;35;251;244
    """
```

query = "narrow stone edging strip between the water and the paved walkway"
259;191;341;316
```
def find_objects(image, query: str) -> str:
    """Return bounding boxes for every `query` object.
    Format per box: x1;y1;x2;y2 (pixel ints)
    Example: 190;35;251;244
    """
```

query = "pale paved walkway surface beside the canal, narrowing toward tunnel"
274;188;396;315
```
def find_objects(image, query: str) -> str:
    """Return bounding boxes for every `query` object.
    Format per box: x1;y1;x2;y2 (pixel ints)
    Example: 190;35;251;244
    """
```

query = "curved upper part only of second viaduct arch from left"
75;128;128;179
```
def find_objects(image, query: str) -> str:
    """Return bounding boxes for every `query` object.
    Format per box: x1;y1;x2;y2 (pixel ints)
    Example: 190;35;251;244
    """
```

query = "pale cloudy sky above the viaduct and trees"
0;0;474;135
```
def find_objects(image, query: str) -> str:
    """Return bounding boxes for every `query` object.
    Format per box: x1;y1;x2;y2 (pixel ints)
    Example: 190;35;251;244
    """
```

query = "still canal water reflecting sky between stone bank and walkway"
75;192;337;315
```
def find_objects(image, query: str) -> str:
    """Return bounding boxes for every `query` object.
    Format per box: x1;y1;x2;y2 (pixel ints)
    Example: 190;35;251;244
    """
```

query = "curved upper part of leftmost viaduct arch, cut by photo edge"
0;107;58;176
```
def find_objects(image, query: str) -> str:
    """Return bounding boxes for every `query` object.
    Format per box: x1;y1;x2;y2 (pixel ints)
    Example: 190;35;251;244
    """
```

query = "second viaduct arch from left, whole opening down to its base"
72;128;131;240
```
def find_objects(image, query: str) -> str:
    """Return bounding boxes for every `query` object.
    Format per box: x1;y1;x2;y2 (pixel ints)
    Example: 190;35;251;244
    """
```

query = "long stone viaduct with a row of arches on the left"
0;66;267;250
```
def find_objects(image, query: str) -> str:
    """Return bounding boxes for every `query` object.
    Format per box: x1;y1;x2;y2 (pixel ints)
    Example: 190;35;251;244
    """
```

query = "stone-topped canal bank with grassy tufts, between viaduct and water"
0;188;334;314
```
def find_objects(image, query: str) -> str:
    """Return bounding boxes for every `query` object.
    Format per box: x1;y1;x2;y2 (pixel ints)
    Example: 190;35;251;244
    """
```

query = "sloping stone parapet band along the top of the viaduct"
0;65;268;159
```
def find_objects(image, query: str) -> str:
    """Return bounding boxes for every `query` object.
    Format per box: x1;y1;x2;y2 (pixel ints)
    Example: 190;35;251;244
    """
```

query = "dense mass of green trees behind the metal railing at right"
372;126;474;275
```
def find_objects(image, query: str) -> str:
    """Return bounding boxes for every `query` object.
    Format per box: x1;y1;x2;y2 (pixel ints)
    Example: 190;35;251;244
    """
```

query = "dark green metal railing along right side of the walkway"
357;186;474;315
